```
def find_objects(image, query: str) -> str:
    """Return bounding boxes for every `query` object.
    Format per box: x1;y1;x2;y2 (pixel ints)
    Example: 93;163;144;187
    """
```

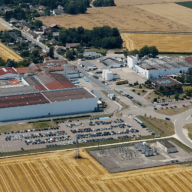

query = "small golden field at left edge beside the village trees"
0;43;22;62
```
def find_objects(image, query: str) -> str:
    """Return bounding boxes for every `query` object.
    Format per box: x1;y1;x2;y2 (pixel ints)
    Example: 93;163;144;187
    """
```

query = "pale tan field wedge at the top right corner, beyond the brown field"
137;3;192;28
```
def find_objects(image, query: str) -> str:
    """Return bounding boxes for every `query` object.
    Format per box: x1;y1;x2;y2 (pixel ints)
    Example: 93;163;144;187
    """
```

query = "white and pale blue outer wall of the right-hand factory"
135;65;188;79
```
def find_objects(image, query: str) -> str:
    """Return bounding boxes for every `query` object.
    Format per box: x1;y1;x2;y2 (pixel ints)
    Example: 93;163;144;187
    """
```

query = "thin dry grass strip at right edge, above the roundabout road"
154;105;192;116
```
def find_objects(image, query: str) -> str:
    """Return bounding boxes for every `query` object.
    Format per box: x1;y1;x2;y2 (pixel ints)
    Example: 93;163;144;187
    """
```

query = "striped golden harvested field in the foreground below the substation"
0;150;192;192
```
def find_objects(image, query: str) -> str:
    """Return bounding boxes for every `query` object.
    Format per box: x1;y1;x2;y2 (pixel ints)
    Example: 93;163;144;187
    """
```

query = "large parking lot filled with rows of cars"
0;115;152;152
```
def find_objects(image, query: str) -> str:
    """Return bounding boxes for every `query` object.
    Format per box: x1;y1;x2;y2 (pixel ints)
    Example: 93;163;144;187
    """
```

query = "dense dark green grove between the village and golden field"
47;26;123;49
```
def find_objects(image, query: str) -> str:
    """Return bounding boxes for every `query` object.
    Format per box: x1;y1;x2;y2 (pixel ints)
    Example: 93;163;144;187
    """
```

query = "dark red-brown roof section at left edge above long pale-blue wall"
0;93;49;108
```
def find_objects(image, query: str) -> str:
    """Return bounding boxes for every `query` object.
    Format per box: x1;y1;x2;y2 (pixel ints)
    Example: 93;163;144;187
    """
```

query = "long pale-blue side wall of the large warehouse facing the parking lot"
0;97;97;121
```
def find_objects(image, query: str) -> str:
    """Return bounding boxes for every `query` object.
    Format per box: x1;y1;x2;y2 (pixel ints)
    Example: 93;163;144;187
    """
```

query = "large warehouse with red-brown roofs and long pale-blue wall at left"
0;73;97;121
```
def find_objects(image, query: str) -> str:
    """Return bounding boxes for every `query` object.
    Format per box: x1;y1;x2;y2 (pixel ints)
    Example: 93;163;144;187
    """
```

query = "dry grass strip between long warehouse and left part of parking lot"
0;121;57;133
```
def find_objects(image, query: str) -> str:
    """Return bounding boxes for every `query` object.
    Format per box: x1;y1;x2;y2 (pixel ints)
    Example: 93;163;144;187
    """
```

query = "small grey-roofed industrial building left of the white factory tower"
99;57;125;68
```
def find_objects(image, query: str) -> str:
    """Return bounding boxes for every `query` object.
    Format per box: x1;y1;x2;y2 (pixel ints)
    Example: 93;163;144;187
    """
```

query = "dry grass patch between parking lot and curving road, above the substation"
138;116;175;137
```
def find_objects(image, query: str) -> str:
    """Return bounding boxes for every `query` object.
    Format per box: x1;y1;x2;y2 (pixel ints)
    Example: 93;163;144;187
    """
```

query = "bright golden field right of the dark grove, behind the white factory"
121;33;192;52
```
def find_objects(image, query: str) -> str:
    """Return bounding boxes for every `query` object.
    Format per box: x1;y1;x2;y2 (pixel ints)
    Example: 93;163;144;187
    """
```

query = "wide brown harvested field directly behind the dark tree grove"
37;6;192;32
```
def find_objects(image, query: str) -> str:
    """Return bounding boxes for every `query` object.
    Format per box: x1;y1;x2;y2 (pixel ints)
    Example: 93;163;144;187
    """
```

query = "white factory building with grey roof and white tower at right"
127;56;192;79
